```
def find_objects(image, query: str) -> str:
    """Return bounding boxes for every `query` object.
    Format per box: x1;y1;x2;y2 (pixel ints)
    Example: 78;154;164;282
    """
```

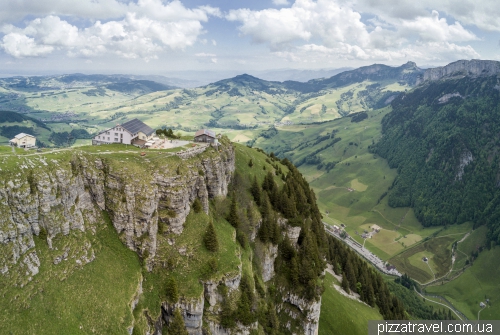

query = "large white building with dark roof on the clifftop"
92;119;155;145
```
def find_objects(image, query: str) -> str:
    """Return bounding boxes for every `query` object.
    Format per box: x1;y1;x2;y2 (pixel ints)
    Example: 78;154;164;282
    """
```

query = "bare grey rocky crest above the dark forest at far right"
417;59;500;85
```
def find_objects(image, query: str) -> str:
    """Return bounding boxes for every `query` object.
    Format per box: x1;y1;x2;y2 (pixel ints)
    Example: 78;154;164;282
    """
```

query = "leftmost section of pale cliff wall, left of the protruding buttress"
0;168;98;273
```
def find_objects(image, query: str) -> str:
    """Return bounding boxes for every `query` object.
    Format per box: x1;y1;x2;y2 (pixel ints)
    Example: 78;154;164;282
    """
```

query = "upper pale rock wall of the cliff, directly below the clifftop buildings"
0;145;235;279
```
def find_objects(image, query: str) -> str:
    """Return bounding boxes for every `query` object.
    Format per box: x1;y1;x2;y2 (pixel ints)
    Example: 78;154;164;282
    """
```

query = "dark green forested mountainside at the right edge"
372;76;500;243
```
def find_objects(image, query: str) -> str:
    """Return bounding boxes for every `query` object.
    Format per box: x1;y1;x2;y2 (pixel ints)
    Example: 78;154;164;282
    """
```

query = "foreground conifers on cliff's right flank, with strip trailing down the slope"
244;153;407;320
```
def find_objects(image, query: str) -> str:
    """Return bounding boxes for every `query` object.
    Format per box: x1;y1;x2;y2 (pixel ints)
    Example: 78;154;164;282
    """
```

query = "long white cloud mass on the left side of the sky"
0;0;220;61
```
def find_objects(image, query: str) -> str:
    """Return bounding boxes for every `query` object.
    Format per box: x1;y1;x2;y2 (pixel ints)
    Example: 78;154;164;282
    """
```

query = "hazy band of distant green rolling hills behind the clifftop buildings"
0;63;422;141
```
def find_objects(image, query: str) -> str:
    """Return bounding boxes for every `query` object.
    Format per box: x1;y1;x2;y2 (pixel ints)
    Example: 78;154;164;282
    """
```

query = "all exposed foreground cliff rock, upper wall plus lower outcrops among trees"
0;144;320;335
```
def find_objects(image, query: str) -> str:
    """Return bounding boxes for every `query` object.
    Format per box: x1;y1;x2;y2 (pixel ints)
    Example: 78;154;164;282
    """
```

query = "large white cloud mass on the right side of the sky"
226;0;479;62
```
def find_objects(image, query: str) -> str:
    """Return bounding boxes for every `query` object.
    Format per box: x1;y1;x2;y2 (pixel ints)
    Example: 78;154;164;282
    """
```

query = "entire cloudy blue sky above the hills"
0;0;500;74
